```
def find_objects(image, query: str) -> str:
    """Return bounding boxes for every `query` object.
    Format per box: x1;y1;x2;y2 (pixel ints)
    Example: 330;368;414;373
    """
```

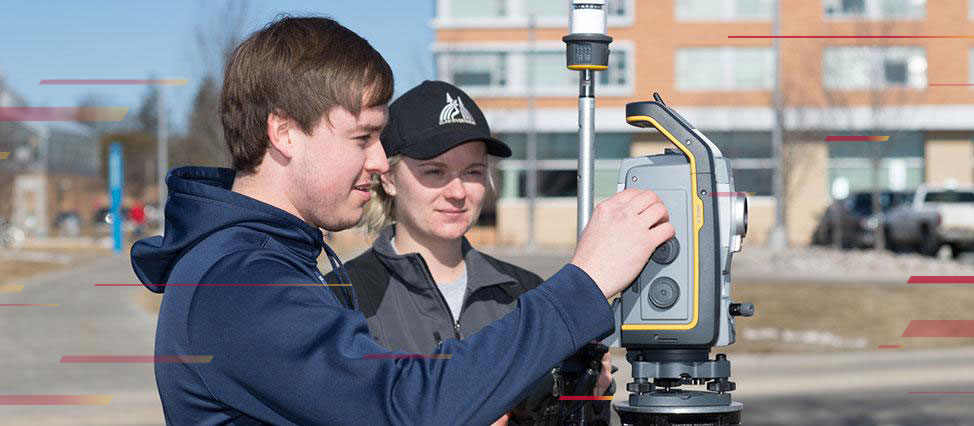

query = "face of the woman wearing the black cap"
383;141;487;240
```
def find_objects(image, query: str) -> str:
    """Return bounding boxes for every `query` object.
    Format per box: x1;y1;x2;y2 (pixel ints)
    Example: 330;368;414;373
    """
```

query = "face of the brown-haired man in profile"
289;105;389;231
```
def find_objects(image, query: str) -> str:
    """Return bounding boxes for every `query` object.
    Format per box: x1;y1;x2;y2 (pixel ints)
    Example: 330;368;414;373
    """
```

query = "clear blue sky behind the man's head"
0;0;434;130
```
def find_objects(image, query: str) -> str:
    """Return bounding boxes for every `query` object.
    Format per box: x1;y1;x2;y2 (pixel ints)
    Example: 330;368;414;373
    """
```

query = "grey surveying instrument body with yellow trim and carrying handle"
613;101;753;350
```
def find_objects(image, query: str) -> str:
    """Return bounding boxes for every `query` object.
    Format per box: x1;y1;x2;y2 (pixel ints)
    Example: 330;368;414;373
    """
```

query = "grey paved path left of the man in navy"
0;256;164;426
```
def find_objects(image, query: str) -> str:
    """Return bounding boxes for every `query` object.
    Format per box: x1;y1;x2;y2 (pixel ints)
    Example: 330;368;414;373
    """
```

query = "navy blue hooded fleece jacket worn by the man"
132;167;613;425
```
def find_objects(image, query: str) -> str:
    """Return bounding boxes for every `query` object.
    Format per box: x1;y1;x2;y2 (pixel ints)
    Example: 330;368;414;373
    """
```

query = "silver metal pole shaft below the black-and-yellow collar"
577;70;595;237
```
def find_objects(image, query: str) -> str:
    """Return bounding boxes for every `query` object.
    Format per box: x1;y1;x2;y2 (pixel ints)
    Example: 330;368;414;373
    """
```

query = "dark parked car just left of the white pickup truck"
812;191;911;248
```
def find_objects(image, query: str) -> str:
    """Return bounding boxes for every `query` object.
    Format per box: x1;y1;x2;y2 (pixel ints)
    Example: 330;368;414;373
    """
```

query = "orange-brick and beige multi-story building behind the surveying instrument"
432;0;974;245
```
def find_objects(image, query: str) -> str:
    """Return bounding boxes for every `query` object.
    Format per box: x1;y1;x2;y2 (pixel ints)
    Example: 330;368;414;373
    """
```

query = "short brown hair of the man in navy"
220;16;393;172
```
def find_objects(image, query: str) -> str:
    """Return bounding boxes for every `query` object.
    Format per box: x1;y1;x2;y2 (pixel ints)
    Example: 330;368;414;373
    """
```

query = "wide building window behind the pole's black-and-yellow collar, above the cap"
436;43;634;97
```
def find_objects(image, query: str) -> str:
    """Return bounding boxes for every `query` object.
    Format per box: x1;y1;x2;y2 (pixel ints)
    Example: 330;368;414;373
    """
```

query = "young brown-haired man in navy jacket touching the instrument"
132;17;673;425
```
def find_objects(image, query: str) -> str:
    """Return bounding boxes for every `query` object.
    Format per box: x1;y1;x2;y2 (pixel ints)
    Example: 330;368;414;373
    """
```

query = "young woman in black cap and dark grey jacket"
329;81;611;424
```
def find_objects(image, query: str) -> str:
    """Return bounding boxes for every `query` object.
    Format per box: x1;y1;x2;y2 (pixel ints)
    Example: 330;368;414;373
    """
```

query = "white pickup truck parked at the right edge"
885;185;974;257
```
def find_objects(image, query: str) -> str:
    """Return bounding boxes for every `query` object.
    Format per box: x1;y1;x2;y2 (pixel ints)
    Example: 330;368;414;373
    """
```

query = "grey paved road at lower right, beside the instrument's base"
614;348;974;426
